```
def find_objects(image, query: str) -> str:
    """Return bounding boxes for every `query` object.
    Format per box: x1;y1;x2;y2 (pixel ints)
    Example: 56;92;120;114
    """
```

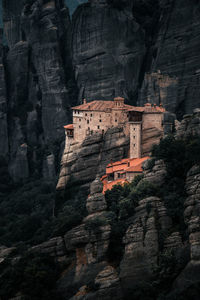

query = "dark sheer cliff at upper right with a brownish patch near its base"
139;0;200;117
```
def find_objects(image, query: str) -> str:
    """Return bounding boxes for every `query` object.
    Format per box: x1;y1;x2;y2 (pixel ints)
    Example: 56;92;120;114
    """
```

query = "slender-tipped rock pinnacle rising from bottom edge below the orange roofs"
58;176;122;300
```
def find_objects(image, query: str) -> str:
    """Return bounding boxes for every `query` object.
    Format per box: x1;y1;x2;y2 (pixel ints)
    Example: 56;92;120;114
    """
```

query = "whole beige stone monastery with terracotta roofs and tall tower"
64;97;172;191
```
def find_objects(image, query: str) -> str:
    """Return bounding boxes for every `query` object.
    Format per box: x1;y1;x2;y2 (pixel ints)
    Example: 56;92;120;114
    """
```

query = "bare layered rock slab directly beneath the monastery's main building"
57;127;129;189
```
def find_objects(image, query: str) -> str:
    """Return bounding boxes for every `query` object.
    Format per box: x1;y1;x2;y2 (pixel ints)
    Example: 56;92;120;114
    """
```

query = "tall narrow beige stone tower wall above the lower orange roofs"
130;122;142;158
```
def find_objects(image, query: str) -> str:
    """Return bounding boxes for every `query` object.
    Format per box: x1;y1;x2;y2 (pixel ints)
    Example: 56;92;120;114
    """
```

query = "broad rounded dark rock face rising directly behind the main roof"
72;1;145;103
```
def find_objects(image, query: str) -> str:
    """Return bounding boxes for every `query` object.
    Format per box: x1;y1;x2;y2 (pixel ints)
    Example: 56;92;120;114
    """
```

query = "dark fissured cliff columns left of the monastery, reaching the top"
1;0;74;181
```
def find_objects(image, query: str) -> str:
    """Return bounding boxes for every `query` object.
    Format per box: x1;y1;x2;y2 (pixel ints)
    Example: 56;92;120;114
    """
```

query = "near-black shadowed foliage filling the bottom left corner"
0;254;62;300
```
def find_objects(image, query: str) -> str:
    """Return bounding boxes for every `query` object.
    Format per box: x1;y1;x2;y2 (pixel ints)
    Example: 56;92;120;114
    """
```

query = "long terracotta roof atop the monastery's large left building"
72;100;133;111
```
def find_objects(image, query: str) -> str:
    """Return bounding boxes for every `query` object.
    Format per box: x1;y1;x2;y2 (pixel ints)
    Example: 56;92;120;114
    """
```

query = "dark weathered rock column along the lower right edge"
169;165;200;299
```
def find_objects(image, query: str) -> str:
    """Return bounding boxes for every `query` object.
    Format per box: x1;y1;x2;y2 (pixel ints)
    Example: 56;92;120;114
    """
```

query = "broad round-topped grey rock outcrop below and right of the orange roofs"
120;197;172;296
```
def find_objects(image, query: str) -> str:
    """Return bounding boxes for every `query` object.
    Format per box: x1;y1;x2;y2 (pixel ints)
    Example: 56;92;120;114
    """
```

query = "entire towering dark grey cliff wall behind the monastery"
1;0;200;180
